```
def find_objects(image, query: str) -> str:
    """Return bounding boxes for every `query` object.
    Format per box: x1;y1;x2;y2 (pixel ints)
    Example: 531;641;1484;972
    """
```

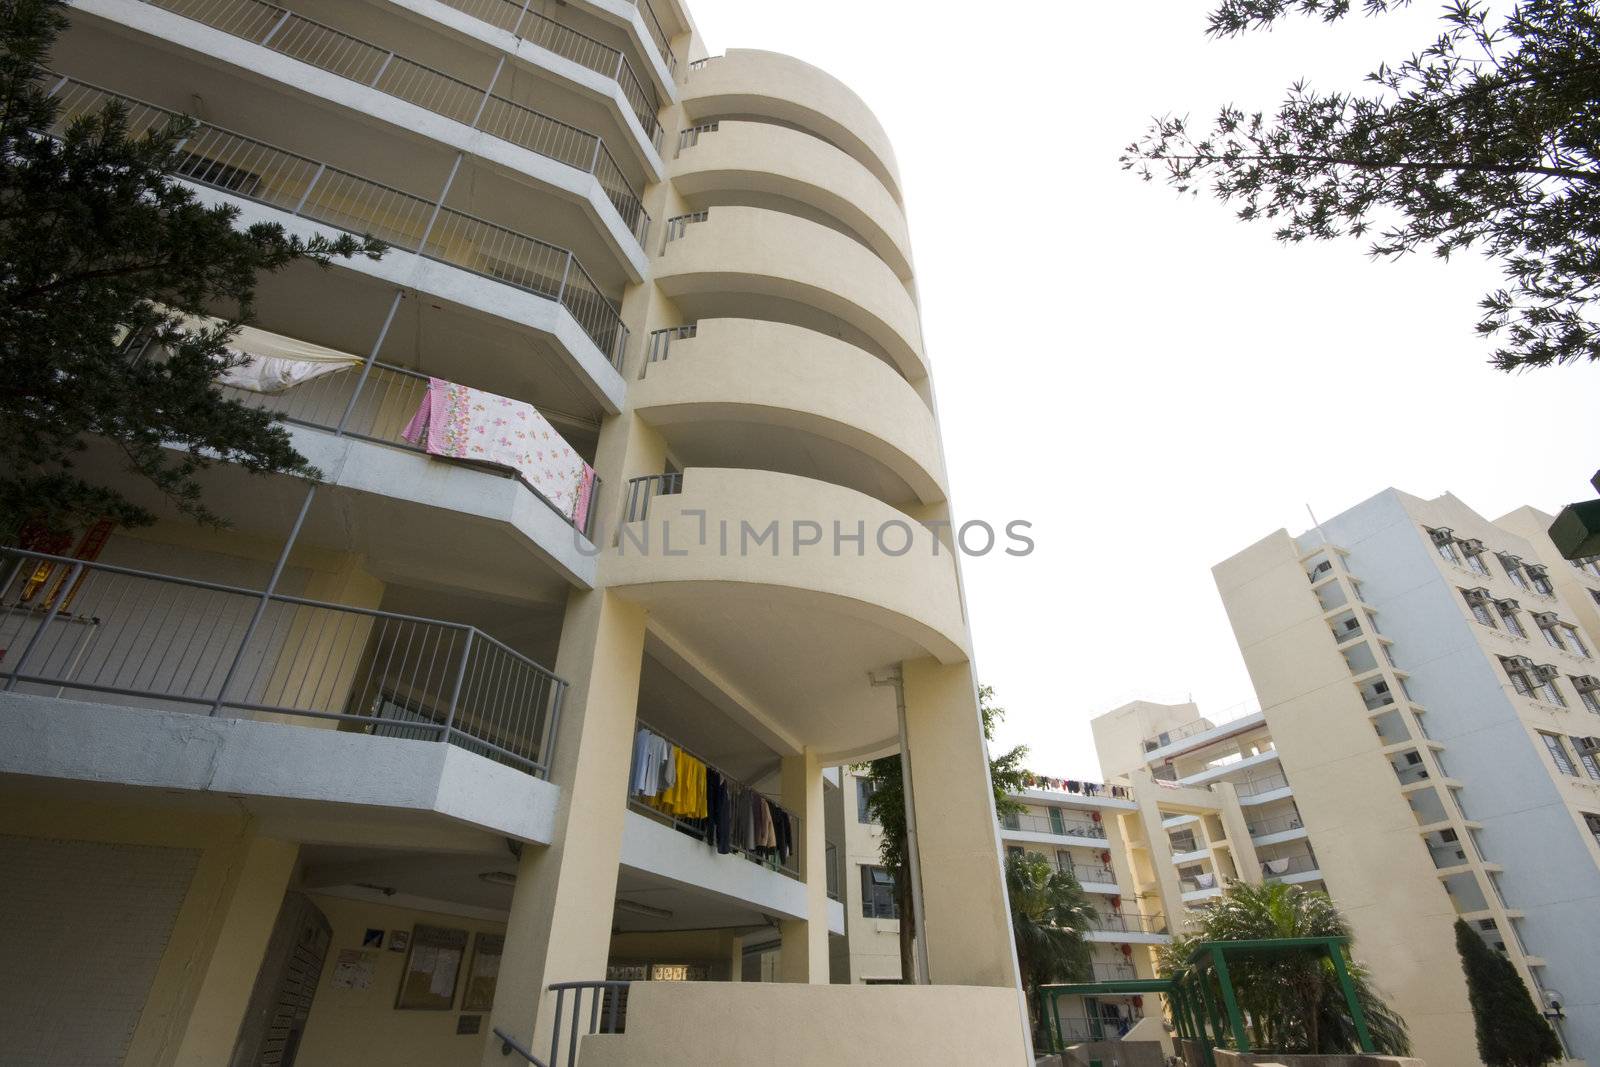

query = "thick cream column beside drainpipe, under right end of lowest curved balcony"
901;657;1018;985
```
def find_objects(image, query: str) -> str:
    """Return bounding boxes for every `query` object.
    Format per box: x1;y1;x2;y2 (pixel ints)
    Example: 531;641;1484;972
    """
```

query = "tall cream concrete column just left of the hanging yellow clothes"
483;590;645;1067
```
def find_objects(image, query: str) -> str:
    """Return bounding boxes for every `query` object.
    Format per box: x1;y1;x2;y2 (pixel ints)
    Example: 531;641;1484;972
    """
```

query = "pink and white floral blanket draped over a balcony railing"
402;378;595;533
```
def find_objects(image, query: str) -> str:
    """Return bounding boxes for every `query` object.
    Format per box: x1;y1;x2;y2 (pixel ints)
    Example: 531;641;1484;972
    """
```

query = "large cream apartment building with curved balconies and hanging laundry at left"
0;0;1029;1067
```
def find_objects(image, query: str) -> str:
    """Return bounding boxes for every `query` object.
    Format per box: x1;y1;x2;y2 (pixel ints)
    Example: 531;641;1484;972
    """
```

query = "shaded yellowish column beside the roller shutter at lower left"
171;837;299;1067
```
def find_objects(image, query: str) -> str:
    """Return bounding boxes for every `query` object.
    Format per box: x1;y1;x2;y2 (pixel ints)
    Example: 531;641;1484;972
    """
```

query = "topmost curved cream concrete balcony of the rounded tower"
683;48;901;200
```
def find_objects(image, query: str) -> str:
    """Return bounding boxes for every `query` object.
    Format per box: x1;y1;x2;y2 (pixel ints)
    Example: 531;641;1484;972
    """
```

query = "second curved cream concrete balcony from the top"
667;122;912;280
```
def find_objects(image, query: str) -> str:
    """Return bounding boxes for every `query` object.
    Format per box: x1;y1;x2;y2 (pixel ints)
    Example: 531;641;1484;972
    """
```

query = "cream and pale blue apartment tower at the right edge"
1203;490;1600;1064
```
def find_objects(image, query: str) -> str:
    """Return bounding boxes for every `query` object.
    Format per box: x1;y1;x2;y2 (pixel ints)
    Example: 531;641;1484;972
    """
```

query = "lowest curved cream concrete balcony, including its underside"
600;467;968;763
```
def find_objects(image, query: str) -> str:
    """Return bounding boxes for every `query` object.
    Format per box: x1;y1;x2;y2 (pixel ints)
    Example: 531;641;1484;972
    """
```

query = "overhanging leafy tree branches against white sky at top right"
1122;0;1600;371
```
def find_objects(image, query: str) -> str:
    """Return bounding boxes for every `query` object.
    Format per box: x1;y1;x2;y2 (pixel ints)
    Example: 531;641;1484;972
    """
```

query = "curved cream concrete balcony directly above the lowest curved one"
632;318;944;506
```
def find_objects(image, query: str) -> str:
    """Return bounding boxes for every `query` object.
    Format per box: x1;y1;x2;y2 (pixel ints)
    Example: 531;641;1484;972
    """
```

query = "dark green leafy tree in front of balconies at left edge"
0;0;382;544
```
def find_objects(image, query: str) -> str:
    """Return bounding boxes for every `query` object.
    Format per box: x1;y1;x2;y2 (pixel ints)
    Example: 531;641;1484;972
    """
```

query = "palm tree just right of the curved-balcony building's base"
1005;853;1096;1022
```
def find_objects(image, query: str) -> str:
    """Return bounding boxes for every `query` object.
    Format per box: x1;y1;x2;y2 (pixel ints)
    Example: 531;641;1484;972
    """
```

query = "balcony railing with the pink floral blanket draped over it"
203;355;600;531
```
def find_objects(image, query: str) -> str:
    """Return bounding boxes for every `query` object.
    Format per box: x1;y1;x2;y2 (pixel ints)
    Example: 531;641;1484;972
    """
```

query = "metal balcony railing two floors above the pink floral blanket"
146;0;650;245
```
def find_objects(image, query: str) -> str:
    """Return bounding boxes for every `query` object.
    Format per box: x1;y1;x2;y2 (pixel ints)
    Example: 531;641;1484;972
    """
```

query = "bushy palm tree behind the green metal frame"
1162;881;1411;1056
